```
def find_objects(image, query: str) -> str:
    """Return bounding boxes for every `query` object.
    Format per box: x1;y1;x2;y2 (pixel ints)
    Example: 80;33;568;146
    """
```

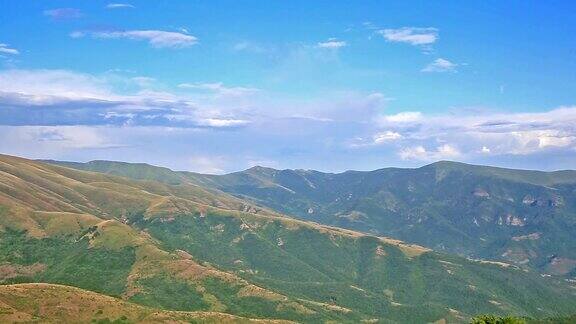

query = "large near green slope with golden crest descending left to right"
0;156;576;322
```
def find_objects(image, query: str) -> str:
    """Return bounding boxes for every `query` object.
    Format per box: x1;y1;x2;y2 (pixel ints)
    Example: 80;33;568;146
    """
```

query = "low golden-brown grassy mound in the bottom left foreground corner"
0;284;290;323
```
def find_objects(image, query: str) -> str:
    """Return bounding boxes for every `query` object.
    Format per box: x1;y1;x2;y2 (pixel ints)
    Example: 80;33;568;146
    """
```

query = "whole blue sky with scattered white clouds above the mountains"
0;0;576;173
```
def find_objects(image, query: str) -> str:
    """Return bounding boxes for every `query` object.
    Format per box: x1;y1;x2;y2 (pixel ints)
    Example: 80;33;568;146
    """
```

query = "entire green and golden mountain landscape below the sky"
0;155;576;323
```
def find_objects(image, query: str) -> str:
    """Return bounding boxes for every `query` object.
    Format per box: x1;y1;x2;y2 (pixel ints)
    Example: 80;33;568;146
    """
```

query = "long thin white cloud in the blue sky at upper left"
70;30;198;48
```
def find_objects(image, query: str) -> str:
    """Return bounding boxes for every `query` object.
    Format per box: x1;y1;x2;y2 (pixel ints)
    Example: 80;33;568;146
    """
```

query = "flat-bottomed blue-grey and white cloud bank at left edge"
0;70;249;128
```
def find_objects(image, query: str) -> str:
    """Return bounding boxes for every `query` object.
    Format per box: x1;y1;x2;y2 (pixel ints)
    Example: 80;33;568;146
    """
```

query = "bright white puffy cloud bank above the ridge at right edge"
374;107;576;160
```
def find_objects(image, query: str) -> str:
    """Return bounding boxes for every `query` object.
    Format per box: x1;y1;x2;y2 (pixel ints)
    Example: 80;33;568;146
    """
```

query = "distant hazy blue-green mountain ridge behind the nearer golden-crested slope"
46;161;576;277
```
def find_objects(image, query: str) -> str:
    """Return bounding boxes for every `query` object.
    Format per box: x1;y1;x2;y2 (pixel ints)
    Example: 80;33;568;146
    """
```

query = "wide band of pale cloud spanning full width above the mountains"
0;70;576;172
